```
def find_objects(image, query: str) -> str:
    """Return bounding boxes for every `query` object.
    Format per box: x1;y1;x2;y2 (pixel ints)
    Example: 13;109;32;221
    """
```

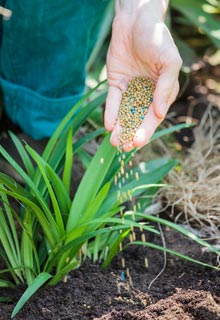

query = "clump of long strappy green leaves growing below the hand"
0;83;216;317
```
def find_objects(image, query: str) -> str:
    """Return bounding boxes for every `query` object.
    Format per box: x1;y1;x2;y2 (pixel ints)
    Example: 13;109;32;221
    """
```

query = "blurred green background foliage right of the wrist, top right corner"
168;0;220;71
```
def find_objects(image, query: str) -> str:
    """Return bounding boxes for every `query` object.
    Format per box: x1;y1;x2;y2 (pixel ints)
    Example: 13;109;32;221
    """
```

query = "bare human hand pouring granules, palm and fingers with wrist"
105;0;182;151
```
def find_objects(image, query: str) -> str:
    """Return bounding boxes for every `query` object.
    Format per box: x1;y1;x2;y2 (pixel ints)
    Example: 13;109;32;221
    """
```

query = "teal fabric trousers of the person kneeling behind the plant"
0;0;109;139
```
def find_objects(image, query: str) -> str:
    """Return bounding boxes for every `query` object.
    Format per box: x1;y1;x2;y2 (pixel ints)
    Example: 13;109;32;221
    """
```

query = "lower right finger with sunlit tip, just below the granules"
133;105;161;148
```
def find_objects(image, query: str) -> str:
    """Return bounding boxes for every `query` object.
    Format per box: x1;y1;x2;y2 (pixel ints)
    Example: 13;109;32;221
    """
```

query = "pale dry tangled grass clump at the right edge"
161;106;220;241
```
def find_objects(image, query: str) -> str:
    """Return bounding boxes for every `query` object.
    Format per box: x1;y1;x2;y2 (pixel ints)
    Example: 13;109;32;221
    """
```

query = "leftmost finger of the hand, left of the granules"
104;86;122;132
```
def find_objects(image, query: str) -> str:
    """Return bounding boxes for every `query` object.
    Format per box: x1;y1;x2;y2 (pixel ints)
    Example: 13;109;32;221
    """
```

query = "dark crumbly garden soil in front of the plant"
0;229;220;320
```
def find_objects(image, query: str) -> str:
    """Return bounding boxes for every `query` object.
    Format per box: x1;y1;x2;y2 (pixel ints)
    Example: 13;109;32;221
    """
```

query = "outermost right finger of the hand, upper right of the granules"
153;55;182;119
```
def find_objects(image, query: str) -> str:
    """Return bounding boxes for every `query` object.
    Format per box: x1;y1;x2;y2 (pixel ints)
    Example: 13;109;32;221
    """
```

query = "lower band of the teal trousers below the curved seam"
0;79;83;140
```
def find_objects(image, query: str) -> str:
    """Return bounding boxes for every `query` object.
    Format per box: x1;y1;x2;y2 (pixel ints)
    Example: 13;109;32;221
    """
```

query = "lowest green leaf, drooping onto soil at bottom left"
11;272;52;318
